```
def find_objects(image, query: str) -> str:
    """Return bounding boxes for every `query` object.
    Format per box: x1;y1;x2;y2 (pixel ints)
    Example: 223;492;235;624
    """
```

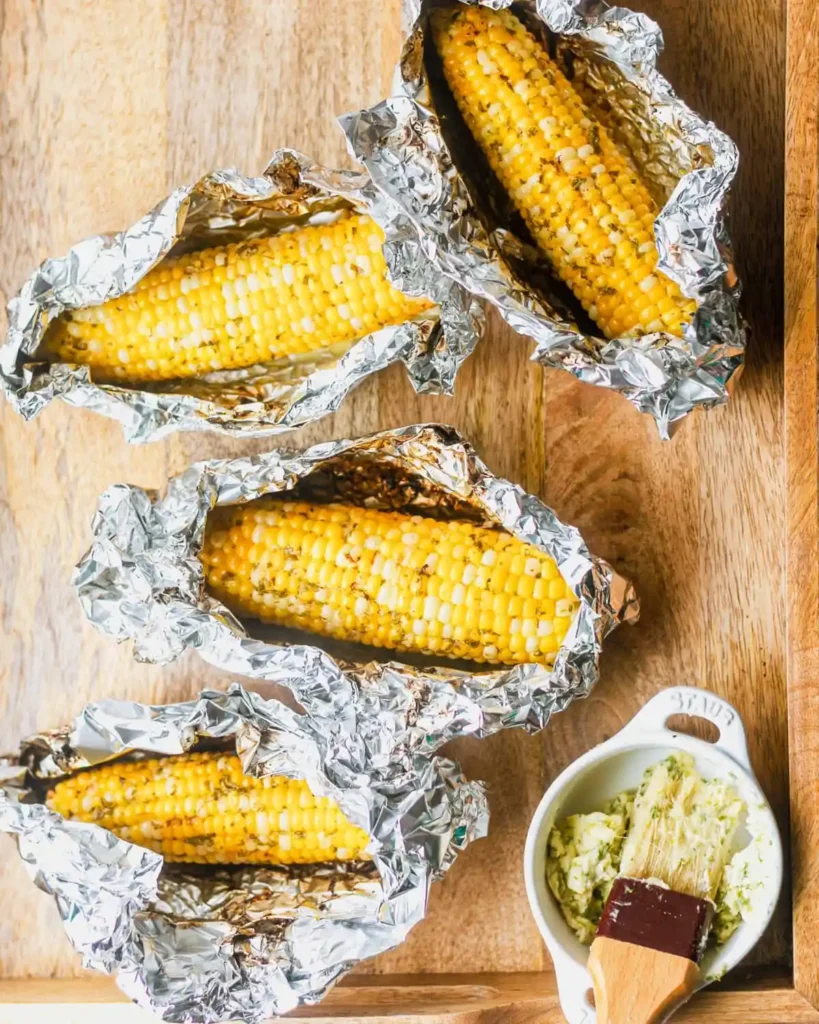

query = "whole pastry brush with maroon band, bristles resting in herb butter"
589;754;743;1024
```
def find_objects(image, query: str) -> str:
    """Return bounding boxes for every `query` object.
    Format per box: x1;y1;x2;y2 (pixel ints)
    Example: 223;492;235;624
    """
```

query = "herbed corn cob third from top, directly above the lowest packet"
200;499;578;665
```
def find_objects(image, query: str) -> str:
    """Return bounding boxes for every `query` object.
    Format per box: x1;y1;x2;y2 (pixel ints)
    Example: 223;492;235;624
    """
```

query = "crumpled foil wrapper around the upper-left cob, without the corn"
0;150;483;441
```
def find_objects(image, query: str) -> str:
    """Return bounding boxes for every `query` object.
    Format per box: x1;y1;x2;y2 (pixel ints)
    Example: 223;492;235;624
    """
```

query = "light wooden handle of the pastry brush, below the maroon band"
588;937;699;1024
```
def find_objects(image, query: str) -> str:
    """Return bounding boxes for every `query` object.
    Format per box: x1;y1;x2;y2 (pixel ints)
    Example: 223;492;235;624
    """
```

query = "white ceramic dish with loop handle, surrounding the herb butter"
523;686;782;1024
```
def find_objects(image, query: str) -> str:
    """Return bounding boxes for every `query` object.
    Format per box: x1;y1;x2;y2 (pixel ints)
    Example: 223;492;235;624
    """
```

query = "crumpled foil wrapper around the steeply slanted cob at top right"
340;0;745;437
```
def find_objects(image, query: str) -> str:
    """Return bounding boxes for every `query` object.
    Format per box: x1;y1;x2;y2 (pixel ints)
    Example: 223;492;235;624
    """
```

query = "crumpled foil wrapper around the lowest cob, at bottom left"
0;684;488;1022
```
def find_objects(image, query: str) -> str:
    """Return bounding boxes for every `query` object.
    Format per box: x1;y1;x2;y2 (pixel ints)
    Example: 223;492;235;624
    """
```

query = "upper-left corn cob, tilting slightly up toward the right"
44;213;431;383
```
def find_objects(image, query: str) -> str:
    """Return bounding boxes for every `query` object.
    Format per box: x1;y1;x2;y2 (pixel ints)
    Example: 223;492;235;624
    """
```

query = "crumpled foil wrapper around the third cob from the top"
74;425;638;753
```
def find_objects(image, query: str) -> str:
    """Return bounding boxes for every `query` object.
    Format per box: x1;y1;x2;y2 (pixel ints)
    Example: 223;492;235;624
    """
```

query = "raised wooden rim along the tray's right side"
785;0;819;1006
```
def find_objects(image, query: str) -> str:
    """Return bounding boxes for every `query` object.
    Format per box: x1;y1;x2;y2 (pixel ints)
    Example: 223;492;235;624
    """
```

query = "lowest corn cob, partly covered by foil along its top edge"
47;753;369;864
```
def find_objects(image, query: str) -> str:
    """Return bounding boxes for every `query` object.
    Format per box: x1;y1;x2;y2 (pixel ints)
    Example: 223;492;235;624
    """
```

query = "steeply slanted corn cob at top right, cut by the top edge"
432;4;696;338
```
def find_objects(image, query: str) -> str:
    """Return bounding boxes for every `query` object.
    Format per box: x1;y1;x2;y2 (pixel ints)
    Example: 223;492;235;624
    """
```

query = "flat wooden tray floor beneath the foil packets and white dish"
0;0;790;1021
